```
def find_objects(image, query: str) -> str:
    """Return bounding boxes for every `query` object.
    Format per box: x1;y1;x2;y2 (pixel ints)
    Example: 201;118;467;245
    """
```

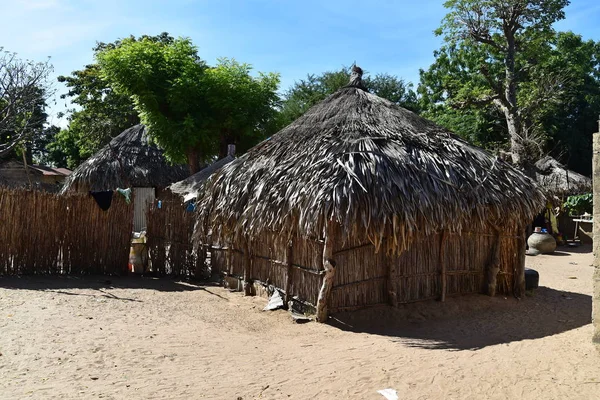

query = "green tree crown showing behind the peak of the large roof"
278;67;418;128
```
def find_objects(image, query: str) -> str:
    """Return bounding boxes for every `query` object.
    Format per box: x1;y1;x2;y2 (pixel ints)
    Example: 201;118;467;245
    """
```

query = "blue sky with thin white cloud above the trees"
0;0;600;122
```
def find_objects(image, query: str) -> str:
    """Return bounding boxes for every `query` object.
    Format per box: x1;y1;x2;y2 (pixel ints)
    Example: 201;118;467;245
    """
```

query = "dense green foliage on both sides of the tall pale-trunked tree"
418;27;600;174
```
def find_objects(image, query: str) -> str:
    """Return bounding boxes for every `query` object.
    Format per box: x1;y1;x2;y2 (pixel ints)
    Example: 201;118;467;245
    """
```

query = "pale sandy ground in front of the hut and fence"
0;248;600;400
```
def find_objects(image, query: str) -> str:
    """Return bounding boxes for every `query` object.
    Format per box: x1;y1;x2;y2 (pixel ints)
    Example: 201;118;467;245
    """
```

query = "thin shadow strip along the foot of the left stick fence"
0;275;226;301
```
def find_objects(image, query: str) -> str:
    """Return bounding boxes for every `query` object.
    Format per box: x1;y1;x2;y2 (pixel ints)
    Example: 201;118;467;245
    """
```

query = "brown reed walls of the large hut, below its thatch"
211;225;525;312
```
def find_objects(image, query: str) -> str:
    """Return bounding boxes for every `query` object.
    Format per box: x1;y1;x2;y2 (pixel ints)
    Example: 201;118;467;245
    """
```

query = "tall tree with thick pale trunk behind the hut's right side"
436;0;569;165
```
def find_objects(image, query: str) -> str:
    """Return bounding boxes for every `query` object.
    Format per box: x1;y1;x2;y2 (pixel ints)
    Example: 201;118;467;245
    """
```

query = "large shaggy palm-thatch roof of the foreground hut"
198;69;543;248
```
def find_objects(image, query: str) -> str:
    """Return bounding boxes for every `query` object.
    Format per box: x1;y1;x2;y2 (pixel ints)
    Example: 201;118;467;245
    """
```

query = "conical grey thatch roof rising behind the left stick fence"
61;125;189;193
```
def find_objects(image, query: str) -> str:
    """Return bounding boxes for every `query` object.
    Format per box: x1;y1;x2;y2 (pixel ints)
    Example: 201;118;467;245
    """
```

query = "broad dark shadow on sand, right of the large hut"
330;287;592;350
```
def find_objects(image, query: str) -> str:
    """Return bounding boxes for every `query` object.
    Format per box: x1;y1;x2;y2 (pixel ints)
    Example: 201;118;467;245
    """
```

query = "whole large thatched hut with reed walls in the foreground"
197;68;543;320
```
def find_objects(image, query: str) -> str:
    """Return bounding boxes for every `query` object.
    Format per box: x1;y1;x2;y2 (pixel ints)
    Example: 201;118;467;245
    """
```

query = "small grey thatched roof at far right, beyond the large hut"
534;156;592;198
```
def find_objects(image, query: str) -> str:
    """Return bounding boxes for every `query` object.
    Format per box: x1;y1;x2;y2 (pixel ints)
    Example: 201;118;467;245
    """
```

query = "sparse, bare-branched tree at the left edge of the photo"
0;48;52;157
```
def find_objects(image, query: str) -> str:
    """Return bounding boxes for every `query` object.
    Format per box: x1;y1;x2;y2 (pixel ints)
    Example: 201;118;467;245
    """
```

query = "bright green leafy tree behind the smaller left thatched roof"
97;38;279;173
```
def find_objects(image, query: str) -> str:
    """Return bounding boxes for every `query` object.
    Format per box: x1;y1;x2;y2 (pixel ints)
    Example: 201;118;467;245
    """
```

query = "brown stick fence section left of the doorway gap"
0;189;133;275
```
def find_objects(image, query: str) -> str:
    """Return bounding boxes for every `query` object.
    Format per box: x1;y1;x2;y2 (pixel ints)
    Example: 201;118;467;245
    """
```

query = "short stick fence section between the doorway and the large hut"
146;199;206;277
